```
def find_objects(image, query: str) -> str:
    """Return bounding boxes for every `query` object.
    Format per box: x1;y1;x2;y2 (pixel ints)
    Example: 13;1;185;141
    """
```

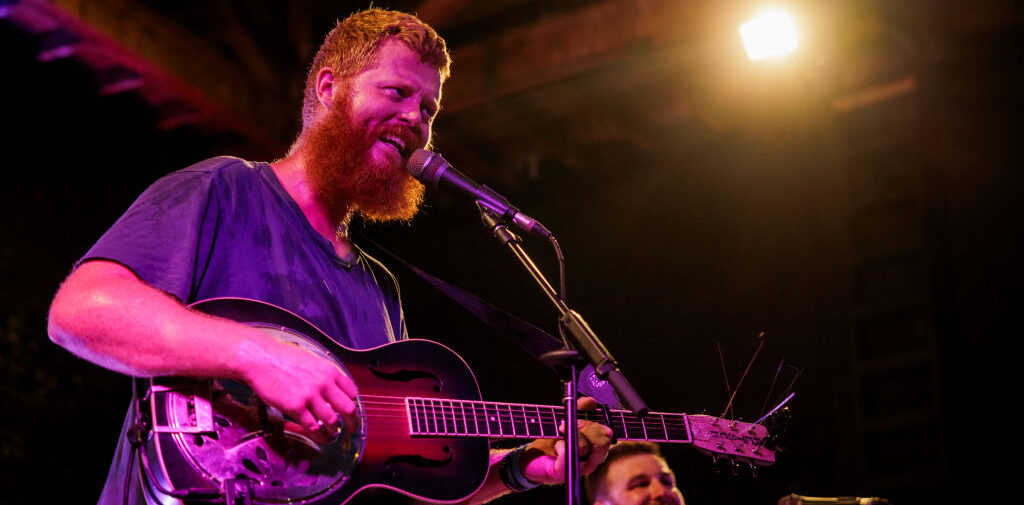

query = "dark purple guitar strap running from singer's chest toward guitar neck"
353;234;623;409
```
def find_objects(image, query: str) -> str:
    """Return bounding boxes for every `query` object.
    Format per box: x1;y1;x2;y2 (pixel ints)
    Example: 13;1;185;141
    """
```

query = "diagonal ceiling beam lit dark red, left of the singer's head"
18;0;298;144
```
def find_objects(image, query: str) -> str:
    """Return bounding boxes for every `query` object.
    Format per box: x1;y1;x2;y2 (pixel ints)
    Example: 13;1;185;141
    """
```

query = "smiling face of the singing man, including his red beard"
308;40;440;222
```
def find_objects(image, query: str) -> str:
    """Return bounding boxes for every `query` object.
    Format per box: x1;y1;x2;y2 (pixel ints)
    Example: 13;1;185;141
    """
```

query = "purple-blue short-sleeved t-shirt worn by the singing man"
87;157;408;504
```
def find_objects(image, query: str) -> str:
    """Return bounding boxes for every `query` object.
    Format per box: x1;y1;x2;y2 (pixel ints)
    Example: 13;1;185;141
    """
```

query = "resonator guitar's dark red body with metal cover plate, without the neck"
143;298;489;505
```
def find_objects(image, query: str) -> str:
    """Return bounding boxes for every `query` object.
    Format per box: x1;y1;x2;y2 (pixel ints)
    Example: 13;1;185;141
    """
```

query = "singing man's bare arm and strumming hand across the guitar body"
49;261;358;431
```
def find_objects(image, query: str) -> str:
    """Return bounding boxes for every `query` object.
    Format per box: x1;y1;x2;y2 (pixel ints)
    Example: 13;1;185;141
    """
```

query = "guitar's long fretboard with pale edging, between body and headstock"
406;397;692;444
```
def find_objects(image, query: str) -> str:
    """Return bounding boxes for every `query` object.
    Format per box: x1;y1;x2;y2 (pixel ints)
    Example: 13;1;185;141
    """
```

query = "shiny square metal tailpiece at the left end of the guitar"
147;381;214;433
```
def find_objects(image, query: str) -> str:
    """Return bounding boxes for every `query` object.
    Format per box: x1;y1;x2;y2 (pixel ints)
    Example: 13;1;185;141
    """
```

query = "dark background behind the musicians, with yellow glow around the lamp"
0;0;1024;505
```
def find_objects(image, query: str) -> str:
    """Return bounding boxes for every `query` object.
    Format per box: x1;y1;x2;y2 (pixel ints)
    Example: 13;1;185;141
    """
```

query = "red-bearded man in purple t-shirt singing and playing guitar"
49;9;610;504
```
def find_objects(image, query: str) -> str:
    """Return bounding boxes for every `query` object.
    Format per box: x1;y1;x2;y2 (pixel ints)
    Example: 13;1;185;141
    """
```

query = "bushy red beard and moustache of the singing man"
306;95;424;224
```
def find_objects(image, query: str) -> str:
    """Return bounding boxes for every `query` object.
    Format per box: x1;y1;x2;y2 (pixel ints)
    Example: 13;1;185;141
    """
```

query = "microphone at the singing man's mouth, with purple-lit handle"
406;150;551;238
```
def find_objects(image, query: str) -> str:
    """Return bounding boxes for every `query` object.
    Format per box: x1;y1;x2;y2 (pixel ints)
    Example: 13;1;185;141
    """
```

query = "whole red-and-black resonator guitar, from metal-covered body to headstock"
139;298;774;505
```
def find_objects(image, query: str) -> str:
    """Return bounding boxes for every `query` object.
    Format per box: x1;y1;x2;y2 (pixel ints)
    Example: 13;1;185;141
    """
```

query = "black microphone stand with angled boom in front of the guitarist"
476;201;648;505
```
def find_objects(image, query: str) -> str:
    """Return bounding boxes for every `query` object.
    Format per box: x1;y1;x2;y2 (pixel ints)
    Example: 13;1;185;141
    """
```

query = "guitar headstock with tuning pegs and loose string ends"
687;415;775;468
